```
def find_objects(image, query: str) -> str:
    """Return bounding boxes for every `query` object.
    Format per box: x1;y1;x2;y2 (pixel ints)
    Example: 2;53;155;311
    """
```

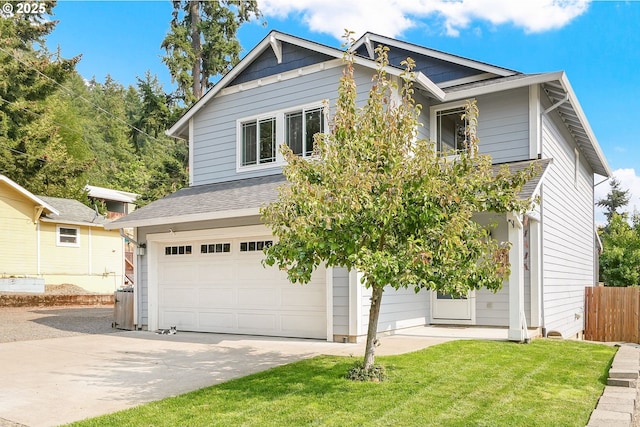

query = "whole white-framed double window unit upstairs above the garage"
237;103;326;170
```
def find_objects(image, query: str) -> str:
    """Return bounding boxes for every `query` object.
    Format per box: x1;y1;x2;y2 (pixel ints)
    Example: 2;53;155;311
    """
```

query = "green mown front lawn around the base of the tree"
73;339;616;426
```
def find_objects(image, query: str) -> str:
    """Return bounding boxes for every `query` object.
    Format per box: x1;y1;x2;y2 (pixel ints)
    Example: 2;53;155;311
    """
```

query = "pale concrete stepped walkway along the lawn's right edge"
587;344;640;427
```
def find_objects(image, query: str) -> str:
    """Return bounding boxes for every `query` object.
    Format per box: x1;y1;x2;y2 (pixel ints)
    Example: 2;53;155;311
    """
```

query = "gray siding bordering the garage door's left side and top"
136;217;260;327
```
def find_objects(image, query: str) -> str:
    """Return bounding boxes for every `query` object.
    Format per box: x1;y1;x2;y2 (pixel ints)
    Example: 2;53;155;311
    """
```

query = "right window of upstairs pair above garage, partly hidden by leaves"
285;108;324;157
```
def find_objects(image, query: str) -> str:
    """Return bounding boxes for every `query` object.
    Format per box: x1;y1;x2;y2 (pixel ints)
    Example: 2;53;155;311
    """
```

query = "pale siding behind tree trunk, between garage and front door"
360;286;431;335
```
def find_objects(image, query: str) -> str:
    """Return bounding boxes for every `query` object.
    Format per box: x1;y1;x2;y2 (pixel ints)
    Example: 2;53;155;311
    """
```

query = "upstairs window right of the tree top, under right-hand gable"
431;103;468;154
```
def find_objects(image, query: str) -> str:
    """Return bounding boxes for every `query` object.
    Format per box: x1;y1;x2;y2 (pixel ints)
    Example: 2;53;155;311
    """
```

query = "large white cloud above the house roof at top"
259;0;591;39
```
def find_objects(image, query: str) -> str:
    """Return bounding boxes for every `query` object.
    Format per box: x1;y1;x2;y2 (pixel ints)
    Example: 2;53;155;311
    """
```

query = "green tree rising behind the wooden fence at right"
600;212;640;286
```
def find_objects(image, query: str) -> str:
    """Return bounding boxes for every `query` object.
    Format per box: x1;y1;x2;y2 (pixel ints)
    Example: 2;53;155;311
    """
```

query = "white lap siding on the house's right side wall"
542;113;595;337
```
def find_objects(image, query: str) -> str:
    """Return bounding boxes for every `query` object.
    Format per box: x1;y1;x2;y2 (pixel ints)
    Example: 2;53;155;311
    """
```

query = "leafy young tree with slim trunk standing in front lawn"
262;39;536;376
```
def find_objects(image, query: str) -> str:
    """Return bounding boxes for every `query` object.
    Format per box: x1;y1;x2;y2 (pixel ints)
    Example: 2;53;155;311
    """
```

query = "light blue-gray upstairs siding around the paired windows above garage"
193;67;371;185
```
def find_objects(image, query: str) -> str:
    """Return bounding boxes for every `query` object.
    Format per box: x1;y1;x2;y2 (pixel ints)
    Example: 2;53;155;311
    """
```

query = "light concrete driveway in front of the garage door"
0;331;451;427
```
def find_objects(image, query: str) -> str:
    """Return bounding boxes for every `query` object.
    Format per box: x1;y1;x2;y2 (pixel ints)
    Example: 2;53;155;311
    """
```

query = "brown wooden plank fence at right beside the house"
584;286;640;344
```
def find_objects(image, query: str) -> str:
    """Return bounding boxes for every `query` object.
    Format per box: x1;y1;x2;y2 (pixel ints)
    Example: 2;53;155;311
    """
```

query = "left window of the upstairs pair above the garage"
242;117;276;166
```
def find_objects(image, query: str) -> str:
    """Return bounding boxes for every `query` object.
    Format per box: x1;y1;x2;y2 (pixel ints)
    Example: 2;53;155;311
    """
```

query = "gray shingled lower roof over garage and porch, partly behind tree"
105;159;551;230
